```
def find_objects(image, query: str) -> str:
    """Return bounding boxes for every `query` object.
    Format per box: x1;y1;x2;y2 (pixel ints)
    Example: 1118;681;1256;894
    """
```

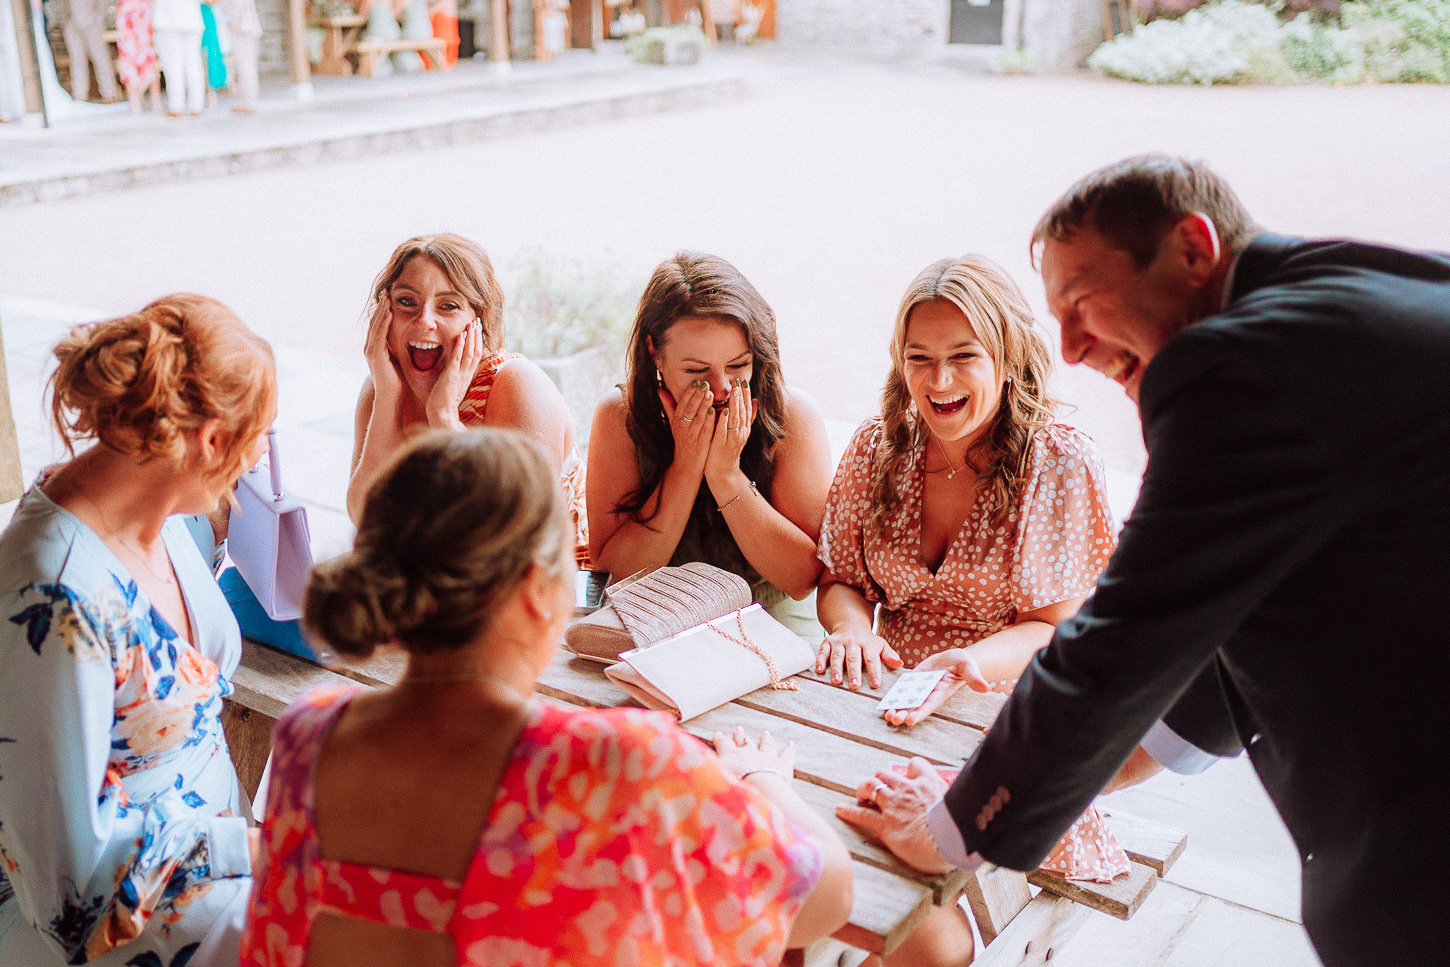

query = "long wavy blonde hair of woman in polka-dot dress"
871;255;1057;528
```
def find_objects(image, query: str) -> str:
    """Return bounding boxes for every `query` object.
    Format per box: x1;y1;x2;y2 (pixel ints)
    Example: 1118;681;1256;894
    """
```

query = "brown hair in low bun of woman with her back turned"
303;429;574;658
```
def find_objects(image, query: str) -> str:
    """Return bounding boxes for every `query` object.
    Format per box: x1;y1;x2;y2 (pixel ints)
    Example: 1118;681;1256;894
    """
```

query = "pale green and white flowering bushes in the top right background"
1088;0;1450;84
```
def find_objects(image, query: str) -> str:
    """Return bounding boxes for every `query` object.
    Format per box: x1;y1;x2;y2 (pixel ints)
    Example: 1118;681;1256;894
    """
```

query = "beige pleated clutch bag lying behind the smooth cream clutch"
564;564;751;663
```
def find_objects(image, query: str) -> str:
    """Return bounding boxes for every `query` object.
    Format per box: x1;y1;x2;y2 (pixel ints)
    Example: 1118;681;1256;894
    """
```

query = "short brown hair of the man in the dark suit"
1032;154;1259;268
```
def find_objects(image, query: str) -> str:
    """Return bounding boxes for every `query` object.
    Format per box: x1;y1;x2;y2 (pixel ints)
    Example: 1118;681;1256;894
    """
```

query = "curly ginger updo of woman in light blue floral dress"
48;293;277;492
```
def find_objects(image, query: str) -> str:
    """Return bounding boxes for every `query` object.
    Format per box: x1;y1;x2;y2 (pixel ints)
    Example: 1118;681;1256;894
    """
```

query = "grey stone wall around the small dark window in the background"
776;0;1102;71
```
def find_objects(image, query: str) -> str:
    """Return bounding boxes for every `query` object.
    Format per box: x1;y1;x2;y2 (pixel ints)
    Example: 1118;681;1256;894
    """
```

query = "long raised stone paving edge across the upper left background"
0;45;745;207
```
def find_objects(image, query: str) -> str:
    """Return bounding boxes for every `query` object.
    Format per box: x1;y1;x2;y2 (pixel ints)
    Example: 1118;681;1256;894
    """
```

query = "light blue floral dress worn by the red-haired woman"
0;487;251;967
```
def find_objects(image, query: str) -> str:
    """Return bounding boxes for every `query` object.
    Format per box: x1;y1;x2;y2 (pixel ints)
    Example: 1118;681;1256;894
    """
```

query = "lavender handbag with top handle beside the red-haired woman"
226;431;312;621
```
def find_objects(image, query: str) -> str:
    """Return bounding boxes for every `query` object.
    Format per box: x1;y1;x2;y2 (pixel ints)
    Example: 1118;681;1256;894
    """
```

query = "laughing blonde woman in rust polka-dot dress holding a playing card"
816;255;1128;966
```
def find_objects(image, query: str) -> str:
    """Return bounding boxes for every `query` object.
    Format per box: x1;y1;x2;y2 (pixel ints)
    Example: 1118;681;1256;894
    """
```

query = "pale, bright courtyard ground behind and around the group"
0;48;1450;964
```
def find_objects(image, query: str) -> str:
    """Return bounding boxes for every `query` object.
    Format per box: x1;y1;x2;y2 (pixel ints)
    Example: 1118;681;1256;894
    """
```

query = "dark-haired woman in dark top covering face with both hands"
589;252;831;635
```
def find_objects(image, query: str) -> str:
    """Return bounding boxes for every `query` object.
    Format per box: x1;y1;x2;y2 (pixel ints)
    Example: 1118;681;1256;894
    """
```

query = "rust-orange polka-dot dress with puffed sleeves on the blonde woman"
819;418;1128;881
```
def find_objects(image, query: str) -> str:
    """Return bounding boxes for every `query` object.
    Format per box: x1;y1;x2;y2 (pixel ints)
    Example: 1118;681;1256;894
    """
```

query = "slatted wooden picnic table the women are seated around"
226;642;1185;963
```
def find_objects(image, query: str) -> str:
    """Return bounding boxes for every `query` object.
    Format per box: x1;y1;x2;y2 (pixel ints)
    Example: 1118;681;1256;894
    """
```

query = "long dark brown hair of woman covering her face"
615;252;786;519
